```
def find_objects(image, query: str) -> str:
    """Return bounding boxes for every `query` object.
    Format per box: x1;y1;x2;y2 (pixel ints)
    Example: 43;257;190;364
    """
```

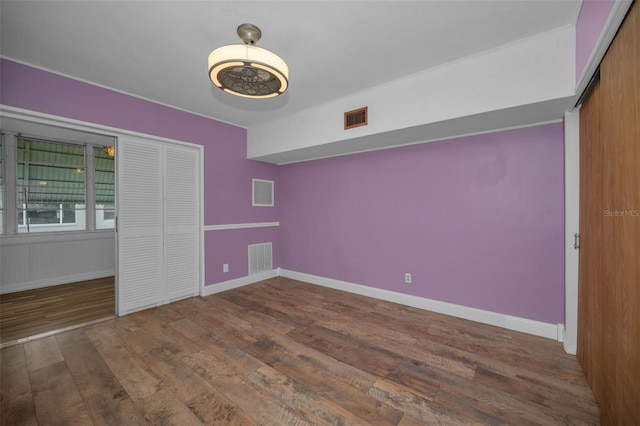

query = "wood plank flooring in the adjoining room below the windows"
0;277;115;346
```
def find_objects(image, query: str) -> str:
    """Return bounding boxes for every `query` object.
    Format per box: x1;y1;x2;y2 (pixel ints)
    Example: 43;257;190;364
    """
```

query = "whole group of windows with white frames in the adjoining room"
0;117;116;238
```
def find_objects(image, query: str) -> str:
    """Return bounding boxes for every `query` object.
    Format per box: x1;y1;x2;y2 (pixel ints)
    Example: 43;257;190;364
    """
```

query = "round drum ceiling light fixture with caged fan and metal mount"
209;24;289;99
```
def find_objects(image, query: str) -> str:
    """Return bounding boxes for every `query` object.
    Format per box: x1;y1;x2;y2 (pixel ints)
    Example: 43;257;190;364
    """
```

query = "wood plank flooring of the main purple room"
1;278;599;426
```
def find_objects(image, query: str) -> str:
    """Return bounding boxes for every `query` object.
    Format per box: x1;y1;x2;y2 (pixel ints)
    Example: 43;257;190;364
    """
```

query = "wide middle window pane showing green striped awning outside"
16;137;86;233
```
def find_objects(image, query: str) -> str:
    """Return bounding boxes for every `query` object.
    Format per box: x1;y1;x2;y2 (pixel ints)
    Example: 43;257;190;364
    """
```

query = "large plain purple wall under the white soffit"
279;124;564;324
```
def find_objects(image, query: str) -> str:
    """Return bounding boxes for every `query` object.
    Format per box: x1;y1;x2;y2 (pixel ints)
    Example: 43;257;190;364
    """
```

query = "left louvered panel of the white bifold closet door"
116;138;166;315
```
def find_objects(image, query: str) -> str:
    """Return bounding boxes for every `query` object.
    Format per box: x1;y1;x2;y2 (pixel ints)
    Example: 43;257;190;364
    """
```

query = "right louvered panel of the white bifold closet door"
164;145;200;302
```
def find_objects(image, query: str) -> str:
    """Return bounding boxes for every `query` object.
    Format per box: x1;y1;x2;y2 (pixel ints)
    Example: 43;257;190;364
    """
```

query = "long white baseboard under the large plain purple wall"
279;269;564;341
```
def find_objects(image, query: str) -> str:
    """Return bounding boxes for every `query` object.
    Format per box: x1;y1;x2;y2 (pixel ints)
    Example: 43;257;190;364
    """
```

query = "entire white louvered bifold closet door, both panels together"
117;137;202;315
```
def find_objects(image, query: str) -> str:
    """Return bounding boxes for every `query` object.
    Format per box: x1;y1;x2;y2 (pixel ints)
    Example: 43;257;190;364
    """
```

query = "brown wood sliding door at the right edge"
578;5;640;425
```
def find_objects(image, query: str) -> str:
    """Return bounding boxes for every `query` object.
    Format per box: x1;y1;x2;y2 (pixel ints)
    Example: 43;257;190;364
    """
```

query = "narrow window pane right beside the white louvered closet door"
93;147;115;229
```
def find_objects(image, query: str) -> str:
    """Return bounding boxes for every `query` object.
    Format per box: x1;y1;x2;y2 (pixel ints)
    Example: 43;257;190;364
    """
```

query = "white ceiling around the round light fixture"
0;0;581;127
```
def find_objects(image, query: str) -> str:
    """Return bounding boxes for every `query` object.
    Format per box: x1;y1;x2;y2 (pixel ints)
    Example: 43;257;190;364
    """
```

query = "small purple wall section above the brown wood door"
576;0;615;81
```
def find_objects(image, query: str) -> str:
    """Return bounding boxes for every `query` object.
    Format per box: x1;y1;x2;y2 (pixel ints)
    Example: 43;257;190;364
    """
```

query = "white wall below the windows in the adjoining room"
0;230;116;293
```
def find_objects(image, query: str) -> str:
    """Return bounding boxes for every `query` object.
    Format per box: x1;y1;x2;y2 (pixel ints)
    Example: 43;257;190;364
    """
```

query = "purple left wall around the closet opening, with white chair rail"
0;59;278;284
